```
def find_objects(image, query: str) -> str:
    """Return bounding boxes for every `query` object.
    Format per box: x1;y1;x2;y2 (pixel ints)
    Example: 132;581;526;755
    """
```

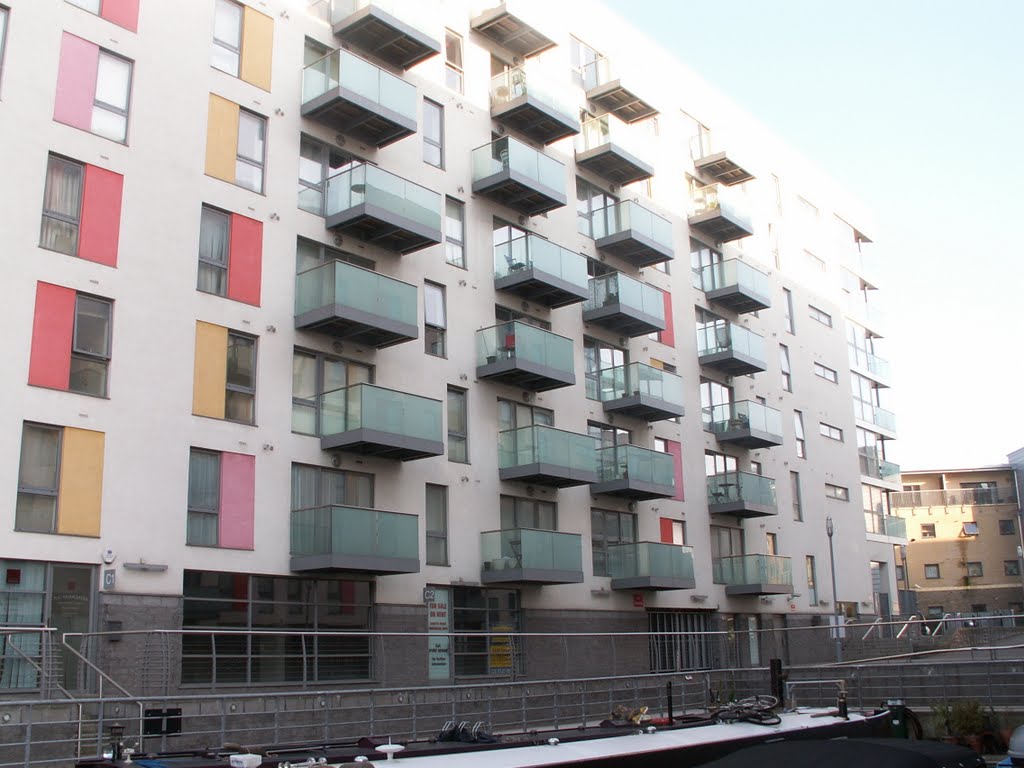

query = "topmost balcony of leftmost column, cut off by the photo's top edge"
331;0;441;70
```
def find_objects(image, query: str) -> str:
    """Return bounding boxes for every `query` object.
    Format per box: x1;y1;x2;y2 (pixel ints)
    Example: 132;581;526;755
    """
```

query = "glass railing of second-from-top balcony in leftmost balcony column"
302;48;418;126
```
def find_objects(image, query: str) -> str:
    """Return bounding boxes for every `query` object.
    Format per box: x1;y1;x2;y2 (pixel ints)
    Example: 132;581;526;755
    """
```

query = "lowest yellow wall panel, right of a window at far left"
57;427;103;537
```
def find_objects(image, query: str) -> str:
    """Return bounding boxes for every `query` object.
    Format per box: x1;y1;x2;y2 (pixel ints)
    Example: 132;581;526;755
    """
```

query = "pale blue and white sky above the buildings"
605;0;1024;469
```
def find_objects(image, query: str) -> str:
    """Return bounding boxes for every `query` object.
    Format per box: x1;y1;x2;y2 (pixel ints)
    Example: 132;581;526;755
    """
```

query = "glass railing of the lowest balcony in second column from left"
480;528;583;577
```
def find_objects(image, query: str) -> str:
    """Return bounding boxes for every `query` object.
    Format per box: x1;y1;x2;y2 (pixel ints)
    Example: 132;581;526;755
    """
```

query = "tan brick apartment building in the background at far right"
891;465;1024;618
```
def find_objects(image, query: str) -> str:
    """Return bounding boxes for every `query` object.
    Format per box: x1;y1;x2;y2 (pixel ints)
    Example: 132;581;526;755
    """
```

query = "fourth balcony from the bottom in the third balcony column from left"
583;272;665;338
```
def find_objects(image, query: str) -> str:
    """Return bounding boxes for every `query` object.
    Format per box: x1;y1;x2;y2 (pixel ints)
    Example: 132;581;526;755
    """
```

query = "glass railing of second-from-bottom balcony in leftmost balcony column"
318;384;442;442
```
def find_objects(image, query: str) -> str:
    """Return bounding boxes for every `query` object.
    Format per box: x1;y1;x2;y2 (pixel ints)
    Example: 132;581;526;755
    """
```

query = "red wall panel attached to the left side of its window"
29;283;75;389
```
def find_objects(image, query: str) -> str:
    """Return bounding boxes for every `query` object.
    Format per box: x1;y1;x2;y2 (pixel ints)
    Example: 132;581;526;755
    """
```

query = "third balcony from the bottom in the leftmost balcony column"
295;261;420;349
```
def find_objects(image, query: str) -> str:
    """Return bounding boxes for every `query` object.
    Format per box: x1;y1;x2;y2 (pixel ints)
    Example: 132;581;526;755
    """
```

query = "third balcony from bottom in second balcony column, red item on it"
476;321;575;392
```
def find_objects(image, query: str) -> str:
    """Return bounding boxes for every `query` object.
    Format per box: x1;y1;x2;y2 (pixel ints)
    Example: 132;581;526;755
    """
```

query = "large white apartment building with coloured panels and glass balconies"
0;0;905;692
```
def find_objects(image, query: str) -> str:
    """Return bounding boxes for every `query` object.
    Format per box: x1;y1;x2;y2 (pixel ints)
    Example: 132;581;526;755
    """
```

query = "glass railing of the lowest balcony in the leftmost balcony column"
291;505;420;561
